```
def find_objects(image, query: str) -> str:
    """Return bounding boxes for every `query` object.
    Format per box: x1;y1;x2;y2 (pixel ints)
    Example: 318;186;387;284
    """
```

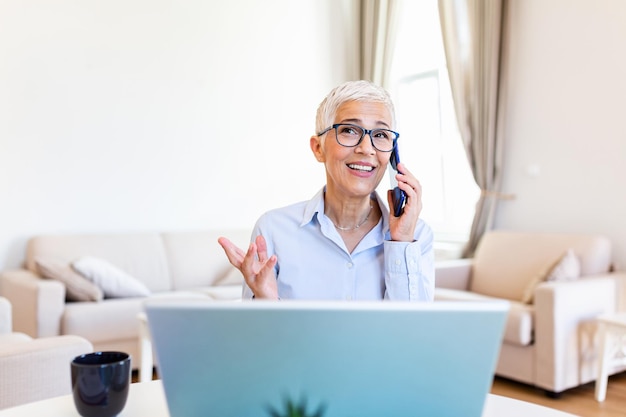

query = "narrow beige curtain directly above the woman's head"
356;0;398;88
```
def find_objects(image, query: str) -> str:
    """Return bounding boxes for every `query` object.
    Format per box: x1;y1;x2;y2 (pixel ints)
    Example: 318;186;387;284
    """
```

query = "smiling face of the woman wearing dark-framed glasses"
311;101;392;197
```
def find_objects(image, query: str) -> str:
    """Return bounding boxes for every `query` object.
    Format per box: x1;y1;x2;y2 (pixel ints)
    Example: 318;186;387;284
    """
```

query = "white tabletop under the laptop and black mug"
0;380;575;417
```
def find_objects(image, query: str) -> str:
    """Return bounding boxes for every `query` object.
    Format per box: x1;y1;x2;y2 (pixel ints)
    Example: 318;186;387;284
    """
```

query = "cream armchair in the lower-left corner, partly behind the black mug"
0;297;93;410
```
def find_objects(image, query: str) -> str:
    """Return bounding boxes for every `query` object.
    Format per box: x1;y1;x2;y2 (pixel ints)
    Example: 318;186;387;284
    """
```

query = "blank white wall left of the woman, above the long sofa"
0;0;354;269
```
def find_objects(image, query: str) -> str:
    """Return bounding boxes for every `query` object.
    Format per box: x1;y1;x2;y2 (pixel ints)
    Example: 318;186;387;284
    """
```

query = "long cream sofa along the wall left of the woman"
0;229;250;368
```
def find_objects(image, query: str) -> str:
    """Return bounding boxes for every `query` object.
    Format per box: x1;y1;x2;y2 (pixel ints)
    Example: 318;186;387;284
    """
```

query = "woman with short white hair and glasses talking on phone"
218;81;435;301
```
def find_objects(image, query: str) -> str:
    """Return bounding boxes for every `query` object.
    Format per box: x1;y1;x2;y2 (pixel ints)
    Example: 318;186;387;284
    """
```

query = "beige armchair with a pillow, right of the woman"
435;231;625;395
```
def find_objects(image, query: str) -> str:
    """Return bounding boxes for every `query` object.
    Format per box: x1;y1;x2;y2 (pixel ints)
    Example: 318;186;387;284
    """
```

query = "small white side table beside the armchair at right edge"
596;313;626;402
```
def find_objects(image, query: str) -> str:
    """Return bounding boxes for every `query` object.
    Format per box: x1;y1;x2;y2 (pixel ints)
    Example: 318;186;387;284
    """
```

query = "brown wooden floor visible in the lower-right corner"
491;372;626;417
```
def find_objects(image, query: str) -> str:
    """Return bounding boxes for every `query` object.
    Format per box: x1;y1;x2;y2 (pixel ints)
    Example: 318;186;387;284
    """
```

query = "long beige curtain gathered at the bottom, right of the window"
439;0;508;257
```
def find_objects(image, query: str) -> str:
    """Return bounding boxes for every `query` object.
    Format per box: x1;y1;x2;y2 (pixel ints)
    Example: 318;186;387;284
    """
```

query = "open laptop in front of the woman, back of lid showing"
146;300;508;417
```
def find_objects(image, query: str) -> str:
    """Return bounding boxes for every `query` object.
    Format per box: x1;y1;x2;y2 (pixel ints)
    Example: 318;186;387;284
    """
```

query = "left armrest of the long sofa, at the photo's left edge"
0;269;65;338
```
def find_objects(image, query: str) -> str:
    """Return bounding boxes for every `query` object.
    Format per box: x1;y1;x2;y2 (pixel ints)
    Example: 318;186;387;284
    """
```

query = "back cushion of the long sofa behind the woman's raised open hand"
162;229;250;290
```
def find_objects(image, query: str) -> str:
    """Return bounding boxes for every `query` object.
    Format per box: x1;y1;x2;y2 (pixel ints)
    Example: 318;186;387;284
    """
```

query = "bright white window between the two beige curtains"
390;0;480;254
